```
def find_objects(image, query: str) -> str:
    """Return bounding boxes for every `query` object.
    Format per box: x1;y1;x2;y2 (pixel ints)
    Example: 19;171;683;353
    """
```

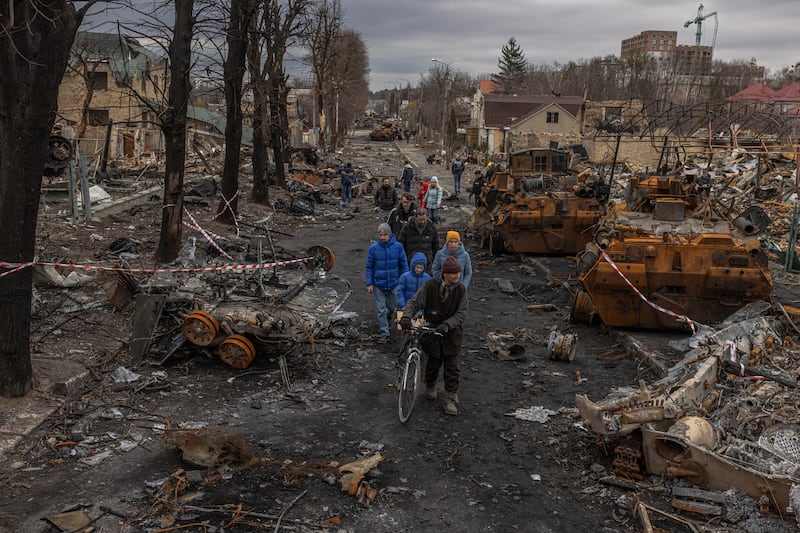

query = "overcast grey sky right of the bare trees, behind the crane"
342;0;800;91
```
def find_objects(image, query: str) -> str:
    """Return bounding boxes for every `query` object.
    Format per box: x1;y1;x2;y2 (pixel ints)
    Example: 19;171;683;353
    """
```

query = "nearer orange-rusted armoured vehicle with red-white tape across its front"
571;170;772;329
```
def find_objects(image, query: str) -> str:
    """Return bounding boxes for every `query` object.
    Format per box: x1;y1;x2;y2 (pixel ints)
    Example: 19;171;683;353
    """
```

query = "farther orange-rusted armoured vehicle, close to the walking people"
468;148;609;255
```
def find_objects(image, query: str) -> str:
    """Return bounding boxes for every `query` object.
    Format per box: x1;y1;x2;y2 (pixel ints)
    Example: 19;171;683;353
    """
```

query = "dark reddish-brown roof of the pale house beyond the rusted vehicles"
483;94;583;128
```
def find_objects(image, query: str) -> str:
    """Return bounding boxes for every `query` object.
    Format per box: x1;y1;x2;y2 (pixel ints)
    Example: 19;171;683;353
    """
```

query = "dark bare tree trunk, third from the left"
217;0;256;224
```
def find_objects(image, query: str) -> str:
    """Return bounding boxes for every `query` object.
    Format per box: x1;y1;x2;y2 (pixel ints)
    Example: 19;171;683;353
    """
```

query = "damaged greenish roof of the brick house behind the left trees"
70;32;164;84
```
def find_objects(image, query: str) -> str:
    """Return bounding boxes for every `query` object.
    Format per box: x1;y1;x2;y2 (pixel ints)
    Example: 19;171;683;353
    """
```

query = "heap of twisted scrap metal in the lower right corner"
576;303;800;515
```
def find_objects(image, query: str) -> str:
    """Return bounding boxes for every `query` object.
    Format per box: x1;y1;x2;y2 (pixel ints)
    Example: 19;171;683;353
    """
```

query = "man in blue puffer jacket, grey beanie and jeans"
365;223;408;342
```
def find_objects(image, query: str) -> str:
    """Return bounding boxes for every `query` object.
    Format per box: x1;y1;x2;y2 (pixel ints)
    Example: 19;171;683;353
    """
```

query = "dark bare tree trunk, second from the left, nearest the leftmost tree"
155;0;195;263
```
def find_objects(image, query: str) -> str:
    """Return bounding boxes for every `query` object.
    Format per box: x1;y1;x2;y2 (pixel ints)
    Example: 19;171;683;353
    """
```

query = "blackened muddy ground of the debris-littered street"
0;132;793;532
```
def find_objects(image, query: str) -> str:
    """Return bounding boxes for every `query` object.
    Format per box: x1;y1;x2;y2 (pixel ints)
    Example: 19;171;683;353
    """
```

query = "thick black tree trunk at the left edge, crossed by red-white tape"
0;1;82;397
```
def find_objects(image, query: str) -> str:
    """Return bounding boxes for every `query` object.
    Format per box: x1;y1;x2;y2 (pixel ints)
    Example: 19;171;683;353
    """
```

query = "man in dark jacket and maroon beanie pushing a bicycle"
400;256;468;415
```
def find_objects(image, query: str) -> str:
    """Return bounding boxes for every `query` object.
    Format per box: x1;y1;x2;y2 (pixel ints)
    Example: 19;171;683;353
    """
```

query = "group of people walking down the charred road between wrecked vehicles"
339;154;472;415
